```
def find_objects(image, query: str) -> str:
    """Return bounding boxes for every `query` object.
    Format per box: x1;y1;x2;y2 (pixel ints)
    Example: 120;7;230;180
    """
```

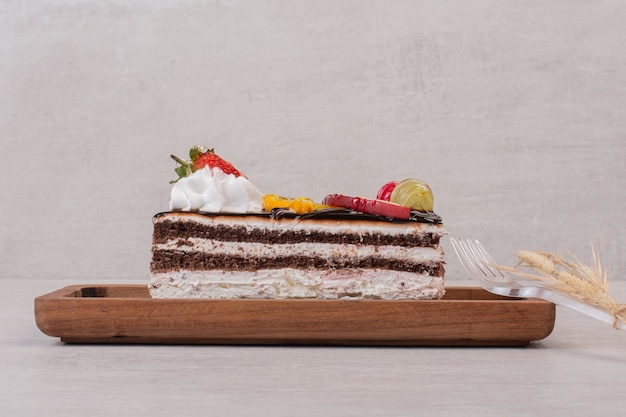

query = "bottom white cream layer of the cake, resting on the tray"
149;268;445;300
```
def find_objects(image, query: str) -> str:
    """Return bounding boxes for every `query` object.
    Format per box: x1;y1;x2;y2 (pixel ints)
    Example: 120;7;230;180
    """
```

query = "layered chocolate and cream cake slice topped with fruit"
149;149;445;300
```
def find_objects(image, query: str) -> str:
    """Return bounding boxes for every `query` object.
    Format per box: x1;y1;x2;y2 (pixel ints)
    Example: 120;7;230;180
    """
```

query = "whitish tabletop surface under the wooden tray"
0;279;626;417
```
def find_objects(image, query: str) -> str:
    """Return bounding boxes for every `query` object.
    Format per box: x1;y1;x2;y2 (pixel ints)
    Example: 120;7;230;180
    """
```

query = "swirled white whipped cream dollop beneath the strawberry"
170;167;263;213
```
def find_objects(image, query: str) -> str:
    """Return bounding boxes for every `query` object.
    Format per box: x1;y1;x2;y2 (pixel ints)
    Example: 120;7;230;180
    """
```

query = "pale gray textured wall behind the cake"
0;0;626;283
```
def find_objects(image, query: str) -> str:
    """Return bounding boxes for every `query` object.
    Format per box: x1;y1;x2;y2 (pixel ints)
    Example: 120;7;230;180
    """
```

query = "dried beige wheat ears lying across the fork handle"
494;248;626;327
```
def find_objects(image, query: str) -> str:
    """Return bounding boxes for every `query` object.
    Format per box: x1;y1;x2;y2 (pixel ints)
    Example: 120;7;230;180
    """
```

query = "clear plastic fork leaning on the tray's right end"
450;237;626;330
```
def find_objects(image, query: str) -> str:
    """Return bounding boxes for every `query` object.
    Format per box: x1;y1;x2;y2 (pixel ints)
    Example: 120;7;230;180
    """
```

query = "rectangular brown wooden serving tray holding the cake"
35;285;555;346
